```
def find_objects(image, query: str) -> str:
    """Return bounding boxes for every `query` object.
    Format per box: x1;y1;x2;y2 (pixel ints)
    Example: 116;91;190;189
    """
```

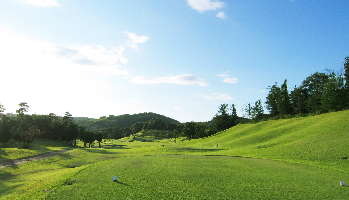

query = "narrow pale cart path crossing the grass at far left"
0;148;73;170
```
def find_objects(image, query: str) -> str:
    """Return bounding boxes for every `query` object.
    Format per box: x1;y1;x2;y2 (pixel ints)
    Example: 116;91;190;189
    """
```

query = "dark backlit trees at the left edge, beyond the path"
0;102;103;148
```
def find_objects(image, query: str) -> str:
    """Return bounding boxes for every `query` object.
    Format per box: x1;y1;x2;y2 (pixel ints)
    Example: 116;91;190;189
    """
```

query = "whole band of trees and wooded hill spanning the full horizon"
0;57;349;148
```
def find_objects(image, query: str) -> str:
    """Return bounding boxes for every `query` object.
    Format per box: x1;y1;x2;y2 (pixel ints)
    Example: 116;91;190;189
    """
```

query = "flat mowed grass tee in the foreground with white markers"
46;155;349;199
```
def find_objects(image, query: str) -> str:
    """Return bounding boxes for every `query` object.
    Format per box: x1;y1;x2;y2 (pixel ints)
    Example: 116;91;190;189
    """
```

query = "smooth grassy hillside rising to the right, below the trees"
186;111;349;170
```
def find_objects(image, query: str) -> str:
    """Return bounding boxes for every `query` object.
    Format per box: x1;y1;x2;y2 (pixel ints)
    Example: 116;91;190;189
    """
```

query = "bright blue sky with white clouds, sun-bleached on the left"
0;0;349;122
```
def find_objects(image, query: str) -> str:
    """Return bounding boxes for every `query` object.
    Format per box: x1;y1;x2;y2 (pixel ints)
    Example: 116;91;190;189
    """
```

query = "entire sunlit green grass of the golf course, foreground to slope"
0;111;349;200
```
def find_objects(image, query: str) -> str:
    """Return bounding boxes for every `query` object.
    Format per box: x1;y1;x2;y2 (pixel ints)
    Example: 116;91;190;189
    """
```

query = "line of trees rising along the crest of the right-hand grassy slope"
178;56;349;139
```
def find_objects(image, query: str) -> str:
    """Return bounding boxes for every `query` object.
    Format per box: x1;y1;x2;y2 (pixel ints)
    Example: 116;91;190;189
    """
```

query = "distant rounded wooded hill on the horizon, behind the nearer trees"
73;112;180;130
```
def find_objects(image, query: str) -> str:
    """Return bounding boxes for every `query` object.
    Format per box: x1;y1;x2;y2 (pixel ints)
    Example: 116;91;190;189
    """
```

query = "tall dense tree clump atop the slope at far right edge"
265;56;349;117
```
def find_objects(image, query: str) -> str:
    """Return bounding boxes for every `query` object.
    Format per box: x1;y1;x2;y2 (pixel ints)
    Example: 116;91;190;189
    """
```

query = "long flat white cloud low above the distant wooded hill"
130;74;209;86
